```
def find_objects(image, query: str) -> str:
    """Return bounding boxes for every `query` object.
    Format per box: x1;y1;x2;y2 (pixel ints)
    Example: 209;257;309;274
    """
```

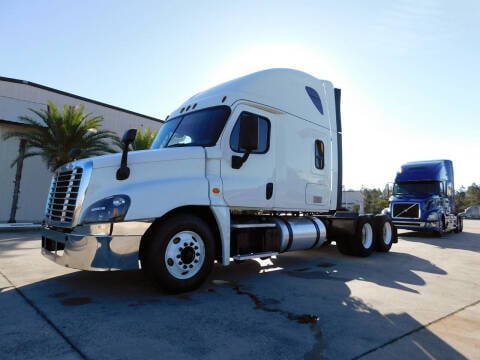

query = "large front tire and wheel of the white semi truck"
142;215;214;293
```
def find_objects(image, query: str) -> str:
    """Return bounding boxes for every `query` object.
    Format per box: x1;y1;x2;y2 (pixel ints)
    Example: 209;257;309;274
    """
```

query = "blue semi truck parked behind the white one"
388;160;463;235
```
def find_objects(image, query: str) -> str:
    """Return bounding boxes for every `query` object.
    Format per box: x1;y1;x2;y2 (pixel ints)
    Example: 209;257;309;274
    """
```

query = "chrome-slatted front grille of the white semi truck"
46;167;83;225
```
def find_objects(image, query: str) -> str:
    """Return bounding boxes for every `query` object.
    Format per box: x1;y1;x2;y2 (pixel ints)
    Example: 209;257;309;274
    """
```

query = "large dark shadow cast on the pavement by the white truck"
0;246;463;359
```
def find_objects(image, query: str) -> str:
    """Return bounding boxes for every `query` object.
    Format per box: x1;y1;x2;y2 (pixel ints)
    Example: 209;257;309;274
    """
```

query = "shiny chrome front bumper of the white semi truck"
42;222;151;270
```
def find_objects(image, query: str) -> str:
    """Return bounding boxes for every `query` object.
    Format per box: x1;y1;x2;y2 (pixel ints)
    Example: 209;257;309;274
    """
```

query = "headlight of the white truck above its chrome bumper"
82;195;130;224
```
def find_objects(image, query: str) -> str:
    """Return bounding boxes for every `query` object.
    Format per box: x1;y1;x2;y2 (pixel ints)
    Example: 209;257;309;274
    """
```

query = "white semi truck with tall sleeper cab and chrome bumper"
42;69;397;292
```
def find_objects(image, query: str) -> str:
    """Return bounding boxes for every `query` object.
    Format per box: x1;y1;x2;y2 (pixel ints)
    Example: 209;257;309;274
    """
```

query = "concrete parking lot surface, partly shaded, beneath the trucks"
0;220;480;360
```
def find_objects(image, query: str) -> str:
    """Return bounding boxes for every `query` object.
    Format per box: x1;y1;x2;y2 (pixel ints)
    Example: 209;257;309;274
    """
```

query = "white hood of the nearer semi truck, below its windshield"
74;147;209;220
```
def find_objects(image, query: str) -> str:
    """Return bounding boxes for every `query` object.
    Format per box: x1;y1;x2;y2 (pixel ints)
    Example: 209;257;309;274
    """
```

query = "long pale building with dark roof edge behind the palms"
0;77;163;223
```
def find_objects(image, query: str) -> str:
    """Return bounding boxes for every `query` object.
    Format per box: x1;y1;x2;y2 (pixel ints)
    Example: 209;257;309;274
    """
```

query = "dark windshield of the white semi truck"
150;106;230;149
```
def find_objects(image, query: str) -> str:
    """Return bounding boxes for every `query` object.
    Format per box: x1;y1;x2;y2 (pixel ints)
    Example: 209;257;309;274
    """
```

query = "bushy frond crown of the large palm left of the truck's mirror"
4;101;119;171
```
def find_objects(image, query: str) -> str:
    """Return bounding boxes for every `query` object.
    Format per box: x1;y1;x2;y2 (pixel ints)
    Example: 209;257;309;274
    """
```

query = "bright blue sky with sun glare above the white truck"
0;0;480;189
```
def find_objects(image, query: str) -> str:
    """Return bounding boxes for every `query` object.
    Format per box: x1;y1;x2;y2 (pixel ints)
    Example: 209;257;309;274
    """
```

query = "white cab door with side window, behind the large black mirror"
221;105;275;209
